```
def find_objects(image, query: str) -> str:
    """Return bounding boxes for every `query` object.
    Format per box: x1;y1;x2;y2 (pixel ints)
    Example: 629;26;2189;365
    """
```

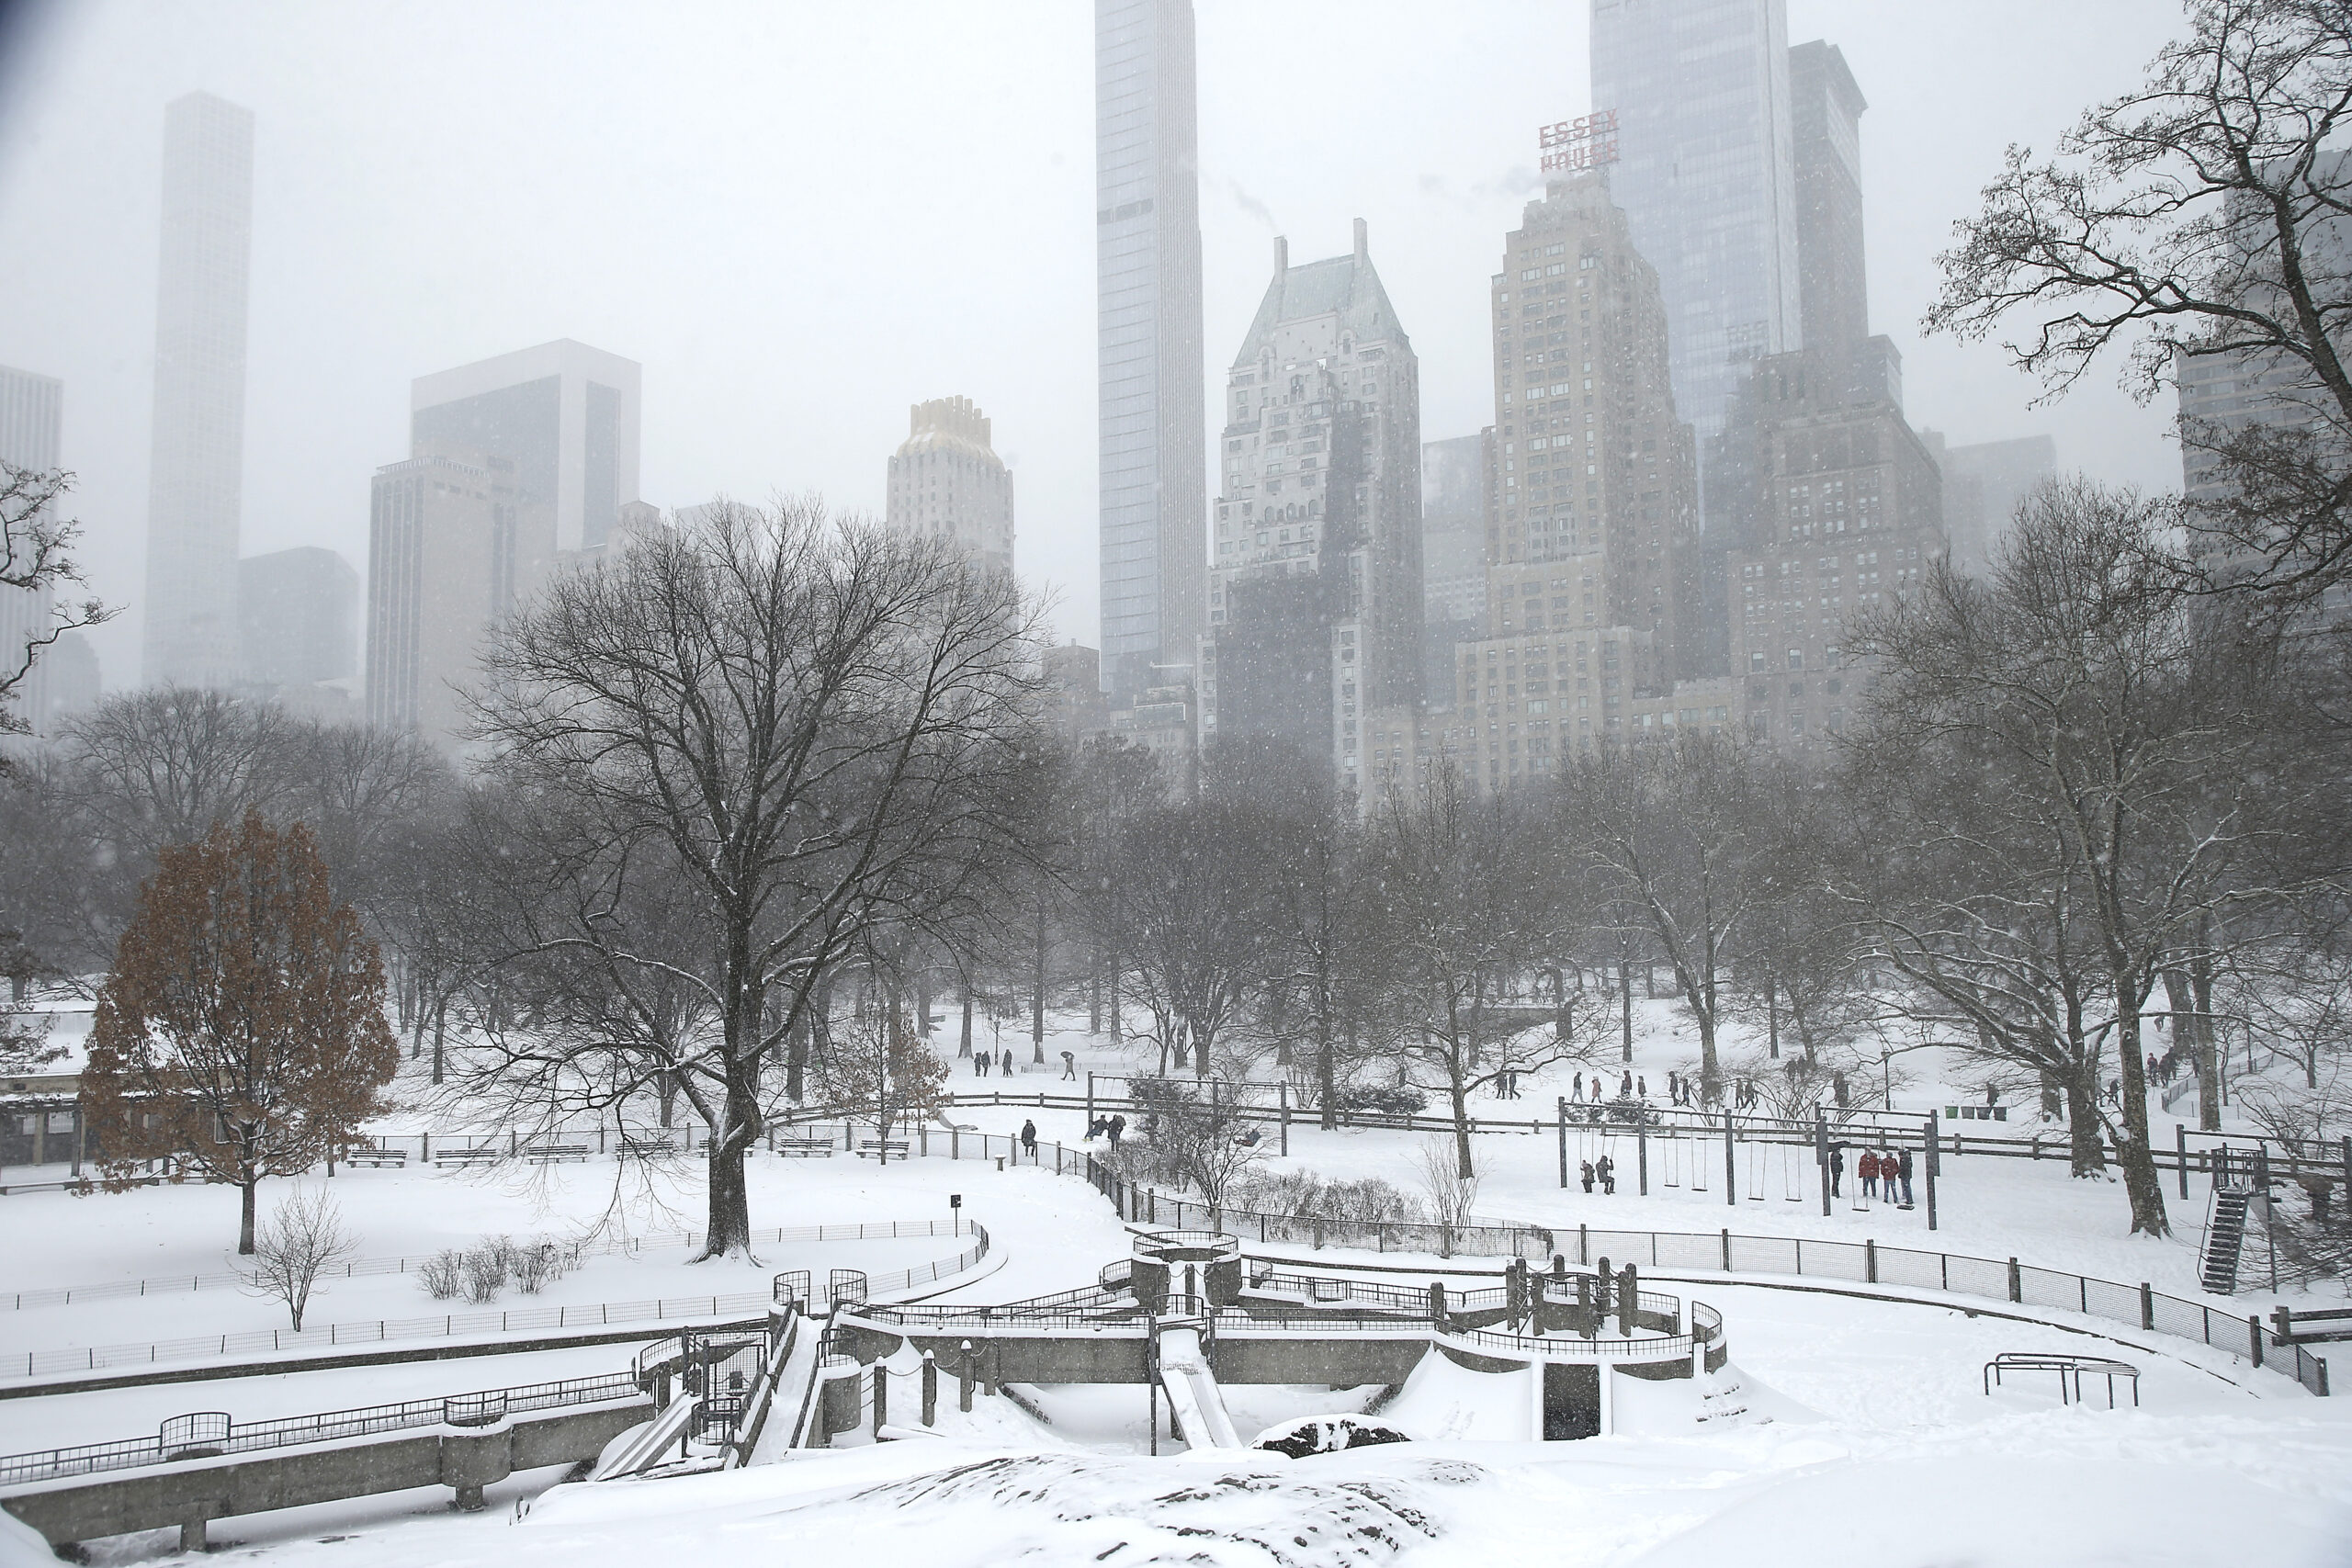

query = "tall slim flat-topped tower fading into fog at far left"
141;92;254;686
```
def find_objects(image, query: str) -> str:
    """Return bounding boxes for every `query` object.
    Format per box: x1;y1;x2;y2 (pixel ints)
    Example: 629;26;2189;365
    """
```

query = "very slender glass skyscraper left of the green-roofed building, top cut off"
1093;0;1209;701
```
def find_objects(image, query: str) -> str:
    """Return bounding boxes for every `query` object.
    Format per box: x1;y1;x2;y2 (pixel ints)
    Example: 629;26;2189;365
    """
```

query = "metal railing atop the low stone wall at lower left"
0;1373;639;1485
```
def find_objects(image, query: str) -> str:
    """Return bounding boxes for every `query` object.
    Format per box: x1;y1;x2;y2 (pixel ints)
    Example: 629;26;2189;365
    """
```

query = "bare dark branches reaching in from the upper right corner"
1927;0;2352;597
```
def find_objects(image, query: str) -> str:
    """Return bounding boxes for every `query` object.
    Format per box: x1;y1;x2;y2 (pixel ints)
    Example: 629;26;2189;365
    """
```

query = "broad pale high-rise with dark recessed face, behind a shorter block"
409;339;642;561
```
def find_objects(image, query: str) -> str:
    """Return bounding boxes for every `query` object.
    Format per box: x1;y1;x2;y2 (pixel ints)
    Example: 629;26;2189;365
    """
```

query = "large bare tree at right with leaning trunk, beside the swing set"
1851;484;2343;1235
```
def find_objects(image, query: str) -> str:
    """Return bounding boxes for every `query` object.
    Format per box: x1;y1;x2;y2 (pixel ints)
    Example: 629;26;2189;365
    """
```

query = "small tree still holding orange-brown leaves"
83;811;400;1253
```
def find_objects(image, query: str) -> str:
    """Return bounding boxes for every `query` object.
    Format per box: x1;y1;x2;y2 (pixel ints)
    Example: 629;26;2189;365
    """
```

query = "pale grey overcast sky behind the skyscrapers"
0;0;2180;686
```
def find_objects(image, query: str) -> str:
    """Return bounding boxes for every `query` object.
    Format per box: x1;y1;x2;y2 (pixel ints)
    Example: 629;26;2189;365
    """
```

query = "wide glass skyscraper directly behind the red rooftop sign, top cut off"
1592;0;1802;465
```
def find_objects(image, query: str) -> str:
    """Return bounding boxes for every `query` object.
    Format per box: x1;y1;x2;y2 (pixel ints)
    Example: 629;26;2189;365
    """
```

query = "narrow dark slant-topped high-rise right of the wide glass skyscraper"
1788;38;1870;348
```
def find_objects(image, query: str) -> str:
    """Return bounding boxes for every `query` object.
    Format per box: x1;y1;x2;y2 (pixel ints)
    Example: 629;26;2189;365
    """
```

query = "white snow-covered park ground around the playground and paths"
0;1004;2352;1568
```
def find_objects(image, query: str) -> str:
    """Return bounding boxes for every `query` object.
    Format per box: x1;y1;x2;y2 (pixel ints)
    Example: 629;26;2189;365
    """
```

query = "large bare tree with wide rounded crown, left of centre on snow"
478;501;1037;1256
